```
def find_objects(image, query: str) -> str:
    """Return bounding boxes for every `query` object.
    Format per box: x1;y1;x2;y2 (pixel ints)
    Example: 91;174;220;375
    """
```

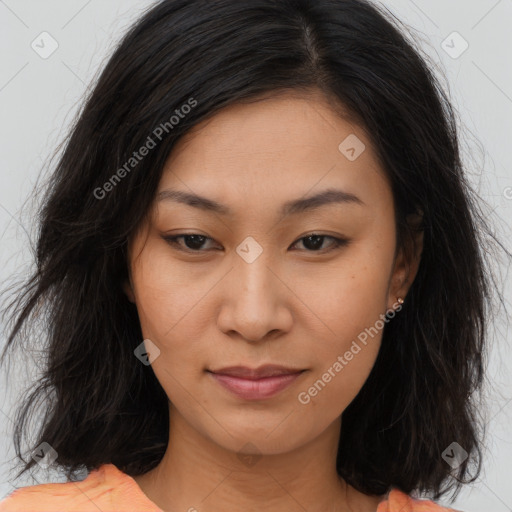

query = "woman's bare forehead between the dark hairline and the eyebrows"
158;93;391;219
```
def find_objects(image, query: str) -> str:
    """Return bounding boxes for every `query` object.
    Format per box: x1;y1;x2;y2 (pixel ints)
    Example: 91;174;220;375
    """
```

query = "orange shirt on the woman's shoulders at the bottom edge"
0;464;462;512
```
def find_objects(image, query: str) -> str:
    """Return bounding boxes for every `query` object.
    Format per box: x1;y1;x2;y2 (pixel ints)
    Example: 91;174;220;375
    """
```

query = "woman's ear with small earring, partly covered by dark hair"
388;212;423;309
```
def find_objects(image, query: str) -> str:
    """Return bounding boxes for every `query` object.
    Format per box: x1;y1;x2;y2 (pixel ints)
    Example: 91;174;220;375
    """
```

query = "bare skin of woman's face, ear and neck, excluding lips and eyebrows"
124;91;422;512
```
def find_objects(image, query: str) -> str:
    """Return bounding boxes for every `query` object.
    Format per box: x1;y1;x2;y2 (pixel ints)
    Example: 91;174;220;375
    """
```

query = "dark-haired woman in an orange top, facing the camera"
0;0;506;512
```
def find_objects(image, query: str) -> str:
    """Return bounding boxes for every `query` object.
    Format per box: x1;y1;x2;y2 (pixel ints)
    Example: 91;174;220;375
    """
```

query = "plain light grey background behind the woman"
0;0;512;512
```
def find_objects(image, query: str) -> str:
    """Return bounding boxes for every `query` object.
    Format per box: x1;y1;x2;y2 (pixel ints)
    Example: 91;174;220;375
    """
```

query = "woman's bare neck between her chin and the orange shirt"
135;410;380;512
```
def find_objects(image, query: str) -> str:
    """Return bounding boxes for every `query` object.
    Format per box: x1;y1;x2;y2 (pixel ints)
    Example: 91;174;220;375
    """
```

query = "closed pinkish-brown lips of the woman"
207;365;305;400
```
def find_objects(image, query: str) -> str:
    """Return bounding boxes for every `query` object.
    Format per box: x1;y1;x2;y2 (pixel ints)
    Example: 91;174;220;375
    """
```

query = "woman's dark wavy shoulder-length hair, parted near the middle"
2;0;510;498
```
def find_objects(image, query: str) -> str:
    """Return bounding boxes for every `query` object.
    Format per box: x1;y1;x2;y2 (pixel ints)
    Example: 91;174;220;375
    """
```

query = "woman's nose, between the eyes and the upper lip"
217;246;293;343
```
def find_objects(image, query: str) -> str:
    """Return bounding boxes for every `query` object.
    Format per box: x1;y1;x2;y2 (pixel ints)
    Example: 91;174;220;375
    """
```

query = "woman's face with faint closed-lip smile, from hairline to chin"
125;94;415;454
